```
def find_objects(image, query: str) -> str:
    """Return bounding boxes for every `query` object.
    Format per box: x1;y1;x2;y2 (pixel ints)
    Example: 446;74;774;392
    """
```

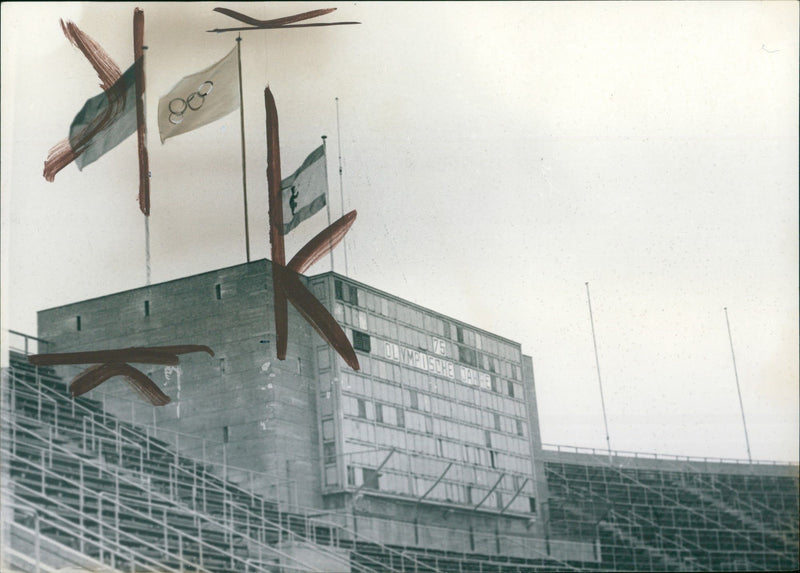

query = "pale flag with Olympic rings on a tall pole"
158;48;239;143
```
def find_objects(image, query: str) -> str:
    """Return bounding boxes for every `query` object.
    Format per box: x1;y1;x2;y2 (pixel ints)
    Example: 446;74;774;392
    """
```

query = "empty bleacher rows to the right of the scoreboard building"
545;456;798;571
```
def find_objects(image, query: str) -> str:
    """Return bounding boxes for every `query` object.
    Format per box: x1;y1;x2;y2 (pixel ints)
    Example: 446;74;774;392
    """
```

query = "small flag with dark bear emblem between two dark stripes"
281;145;328;235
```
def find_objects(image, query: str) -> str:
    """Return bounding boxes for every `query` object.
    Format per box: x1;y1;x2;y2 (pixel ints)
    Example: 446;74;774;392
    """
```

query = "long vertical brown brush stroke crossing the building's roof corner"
264;86;289;360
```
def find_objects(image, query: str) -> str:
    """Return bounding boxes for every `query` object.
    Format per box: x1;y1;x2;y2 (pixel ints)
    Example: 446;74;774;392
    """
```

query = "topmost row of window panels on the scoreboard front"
334;279;521;362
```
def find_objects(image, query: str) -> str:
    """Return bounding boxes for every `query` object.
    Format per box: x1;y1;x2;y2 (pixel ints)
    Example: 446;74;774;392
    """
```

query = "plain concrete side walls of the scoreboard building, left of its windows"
39;260;321;507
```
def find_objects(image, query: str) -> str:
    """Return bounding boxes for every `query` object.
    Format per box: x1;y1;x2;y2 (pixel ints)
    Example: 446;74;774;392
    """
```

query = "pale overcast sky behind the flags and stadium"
2;2;800;461
